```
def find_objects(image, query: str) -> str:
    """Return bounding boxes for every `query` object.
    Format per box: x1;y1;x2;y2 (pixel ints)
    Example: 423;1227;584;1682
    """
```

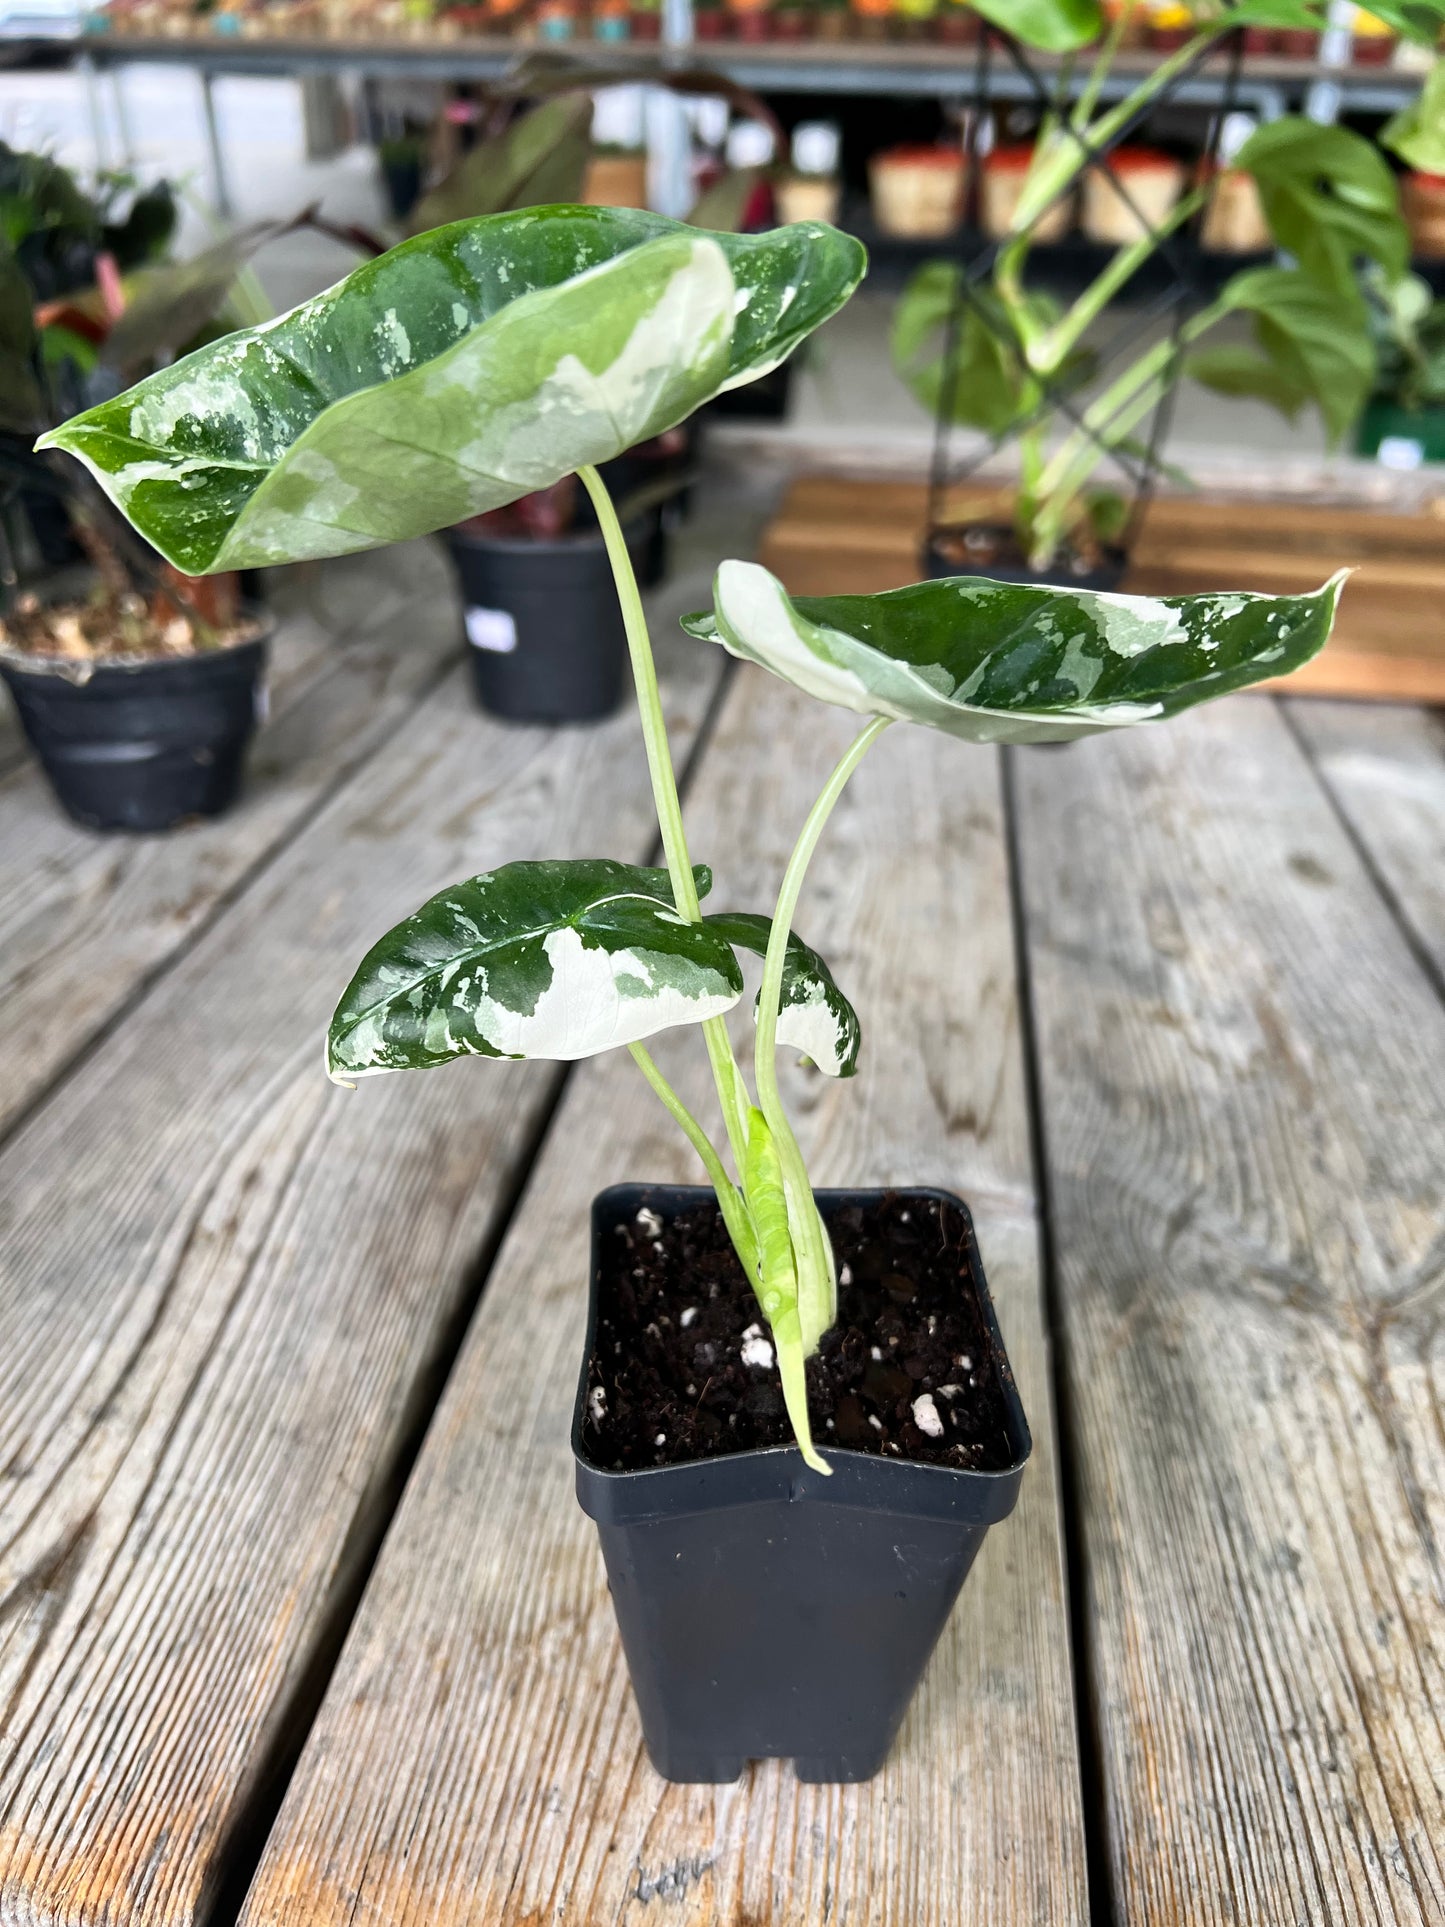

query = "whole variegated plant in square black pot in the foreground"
46;206;1339;1779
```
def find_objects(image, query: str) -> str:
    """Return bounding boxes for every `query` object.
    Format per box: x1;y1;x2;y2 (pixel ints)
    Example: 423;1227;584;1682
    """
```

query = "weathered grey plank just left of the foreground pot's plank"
0;508;721;1927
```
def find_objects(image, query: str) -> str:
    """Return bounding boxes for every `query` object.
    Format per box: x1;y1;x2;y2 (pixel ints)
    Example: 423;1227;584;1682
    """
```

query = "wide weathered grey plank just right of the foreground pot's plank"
1017;700;1445;1927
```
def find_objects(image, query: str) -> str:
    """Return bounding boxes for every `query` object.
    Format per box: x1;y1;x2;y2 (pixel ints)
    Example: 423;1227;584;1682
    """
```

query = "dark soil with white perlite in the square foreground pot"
586;1193;1013;1472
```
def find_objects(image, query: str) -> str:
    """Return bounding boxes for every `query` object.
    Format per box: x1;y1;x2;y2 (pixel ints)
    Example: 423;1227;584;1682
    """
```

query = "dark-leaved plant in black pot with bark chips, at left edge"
0;148;331;831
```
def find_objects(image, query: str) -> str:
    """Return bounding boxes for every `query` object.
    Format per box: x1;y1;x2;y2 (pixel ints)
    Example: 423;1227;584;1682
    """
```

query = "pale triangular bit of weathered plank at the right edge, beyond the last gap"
1289;703;1445;983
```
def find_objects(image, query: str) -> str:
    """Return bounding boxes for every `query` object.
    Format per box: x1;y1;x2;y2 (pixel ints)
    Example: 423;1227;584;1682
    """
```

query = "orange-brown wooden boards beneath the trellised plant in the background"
761;476;1445;703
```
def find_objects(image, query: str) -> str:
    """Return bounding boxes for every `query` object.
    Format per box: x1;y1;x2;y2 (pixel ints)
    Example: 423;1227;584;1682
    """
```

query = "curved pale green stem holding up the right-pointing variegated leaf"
753;717;890;1357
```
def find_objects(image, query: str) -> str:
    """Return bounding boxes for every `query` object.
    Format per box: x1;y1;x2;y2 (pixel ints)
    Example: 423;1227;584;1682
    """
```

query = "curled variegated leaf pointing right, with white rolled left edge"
684;563;1345;742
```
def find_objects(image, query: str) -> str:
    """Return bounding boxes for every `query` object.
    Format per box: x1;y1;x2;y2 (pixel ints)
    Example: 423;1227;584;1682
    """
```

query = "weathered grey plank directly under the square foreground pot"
245;671;1087;1927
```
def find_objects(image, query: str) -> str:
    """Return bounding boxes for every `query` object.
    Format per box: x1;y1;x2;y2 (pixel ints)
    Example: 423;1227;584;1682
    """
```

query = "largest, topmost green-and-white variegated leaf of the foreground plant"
44;206;865;574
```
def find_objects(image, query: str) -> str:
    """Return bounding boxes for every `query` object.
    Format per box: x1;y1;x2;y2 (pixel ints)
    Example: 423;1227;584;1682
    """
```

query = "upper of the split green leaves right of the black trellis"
1235;118;1410;295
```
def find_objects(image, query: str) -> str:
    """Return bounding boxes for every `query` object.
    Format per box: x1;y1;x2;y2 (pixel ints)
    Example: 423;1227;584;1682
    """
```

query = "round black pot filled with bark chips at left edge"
0;634;270;831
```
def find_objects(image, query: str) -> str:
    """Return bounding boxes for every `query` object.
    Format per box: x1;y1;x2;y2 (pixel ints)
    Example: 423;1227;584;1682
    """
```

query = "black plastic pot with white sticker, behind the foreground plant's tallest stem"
447;528;644;723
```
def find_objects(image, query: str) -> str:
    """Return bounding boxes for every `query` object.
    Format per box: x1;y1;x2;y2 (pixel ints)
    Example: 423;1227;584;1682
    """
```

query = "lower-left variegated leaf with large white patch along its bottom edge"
326;858;742;1083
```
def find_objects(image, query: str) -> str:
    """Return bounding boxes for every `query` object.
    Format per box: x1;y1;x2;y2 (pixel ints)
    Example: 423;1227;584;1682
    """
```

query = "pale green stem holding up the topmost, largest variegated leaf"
578;466;748;1172
